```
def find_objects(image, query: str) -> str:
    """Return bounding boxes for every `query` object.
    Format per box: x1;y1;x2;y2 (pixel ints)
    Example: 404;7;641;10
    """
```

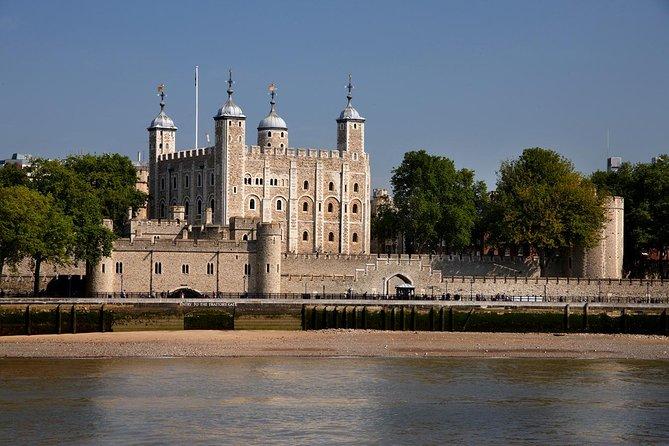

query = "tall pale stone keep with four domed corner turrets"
147;75;370;254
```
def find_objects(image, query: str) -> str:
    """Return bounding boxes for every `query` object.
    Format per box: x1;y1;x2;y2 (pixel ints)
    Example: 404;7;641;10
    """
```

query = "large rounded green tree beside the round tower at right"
490;147;605;275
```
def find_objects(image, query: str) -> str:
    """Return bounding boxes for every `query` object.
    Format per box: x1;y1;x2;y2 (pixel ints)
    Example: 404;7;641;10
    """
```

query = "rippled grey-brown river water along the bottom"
0;358;669;445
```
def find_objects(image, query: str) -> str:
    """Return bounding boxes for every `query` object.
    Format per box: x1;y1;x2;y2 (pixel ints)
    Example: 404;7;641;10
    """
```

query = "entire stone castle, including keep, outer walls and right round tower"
11;73;638;295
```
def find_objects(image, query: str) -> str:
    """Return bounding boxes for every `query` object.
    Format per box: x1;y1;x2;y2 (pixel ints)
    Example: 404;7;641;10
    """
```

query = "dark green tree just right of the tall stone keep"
391;150;477;253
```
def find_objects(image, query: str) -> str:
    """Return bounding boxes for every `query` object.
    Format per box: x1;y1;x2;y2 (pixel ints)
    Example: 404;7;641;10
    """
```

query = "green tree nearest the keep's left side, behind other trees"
64;153;147;235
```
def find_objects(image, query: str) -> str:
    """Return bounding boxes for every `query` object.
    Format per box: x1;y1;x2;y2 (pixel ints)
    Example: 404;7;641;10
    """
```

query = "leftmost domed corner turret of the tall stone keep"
147;85;177;218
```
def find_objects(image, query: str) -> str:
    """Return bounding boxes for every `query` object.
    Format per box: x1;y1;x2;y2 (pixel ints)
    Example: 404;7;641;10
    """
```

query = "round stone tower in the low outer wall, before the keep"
256;223;281;294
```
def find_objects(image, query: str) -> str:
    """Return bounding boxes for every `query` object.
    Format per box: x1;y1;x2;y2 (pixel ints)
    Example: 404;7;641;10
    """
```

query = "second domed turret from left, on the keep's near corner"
212;71;246;225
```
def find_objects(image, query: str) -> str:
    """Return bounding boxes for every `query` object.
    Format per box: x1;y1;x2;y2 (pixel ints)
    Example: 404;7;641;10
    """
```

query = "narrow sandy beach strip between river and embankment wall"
0;330;669;360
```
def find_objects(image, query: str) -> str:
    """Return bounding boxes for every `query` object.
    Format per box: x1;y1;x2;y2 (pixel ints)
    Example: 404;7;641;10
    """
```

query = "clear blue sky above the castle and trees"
0;0;669;187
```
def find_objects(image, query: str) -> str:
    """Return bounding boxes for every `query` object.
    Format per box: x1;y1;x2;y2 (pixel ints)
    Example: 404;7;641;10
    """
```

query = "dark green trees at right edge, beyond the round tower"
592;155;669;277
